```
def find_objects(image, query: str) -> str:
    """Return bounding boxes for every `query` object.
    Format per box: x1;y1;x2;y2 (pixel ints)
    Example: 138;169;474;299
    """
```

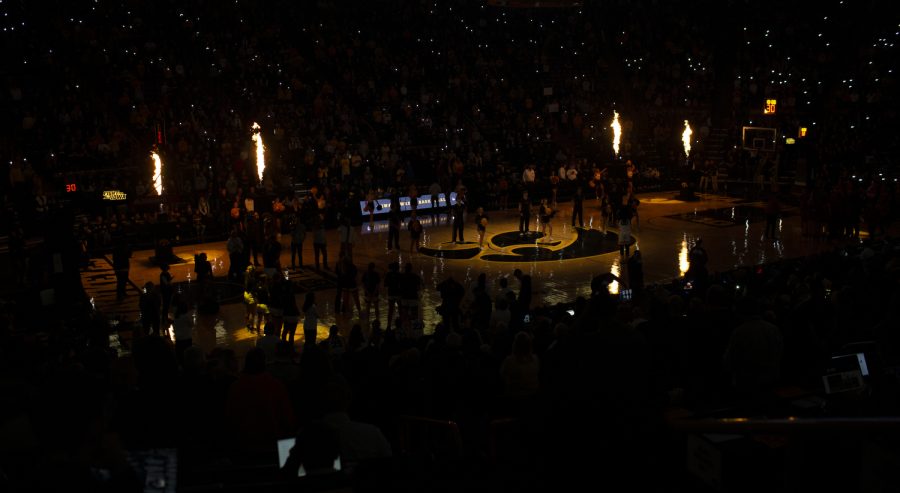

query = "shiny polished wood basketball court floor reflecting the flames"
82;192;833;352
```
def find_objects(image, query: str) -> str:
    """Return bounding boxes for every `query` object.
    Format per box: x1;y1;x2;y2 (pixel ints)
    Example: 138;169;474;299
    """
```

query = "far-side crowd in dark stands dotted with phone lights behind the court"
3;2;893;242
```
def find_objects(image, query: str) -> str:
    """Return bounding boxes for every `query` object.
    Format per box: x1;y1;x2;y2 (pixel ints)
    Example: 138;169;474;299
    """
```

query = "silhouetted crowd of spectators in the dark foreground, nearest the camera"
0;226;900;491
